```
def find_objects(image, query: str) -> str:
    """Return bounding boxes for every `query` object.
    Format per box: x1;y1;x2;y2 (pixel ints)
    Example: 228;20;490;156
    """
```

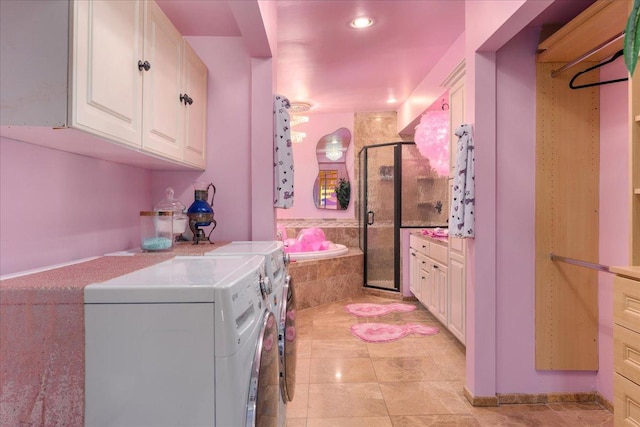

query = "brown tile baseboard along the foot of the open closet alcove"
464;387;613;413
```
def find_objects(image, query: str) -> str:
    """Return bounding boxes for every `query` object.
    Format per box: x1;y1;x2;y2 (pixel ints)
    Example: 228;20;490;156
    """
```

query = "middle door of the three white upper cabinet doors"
143;1;184;161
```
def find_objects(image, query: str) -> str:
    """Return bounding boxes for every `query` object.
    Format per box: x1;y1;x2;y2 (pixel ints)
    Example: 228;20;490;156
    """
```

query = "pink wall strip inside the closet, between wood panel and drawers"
597;58;630;401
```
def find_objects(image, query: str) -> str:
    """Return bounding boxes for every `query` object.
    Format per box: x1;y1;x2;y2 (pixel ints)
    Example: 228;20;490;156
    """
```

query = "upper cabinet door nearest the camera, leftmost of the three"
73;0;143;147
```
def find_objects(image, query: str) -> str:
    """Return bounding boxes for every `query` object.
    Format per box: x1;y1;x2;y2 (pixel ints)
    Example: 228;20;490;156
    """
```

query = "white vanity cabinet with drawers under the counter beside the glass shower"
409;234;466;344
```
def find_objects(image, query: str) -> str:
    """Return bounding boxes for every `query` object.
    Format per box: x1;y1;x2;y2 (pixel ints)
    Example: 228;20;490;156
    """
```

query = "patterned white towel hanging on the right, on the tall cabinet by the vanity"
449;124;476;238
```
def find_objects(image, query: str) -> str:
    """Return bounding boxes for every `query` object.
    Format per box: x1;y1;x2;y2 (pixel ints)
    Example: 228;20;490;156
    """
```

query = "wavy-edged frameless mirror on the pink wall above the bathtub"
313;128;351;210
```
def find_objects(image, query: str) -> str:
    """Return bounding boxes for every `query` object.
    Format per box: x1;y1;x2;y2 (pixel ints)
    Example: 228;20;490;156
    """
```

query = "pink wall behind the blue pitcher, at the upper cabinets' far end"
151;37;254;241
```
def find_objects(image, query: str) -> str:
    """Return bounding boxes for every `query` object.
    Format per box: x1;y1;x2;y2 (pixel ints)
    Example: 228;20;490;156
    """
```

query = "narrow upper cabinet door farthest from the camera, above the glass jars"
182;41;207;169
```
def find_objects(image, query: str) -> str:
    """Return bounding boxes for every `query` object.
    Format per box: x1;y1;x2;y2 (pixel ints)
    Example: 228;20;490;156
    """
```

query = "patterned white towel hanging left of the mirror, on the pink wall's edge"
273;95;293;209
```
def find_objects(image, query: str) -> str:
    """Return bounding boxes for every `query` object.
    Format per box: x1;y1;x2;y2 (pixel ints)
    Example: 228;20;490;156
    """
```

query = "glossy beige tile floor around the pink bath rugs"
287;295;613;427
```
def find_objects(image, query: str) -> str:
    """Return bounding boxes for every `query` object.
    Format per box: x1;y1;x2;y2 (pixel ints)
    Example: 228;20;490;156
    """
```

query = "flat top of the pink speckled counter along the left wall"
0;242;228;305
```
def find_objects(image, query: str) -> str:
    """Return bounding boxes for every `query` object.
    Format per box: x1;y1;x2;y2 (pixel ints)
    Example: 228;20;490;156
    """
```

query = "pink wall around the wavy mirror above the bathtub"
276;113;357;219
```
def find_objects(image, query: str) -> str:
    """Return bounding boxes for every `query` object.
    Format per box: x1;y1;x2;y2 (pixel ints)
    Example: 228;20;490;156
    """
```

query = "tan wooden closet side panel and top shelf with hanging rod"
535;0;640;371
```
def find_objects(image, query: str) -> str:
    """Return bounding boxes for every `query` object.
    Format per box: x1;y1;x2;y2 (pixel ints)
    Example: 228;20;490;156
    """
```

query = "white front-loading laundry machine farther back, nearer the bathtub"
205;241;297;426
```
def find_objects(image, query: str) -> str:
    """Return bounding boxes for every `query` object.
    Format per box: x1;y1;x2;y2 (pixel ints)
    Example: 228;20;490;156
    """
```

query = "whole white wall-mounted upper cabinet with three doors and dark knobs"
1;0;207;169
